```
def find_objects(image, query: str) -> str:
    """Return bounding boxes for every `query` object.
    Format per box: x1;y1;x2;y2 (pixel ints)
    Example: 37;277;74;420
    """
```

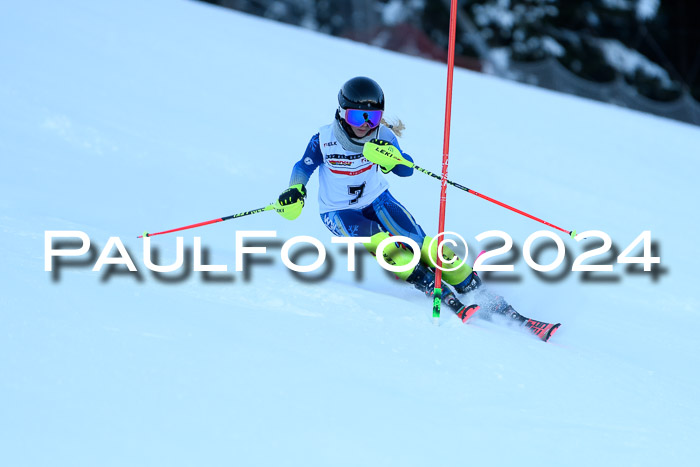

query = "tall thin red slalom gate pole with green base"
433;0;457;324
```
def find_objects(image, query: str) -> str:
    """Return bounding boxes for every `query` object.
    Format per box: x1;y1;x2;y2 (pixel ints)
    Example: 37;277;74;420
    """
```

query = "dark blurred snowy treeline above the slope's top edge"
205;0;700;101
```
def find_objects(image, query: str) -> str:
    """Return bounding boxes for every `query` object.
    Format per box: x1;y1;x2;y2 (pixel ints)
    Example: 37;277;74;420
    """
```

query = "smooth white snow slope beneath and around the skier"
0;0;700;466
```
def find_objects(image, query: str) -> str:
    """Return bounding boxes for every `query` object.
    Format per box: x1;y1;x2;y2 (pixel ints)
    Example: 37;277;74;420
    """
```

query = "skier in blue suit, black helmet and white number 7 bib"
278;76;559;341
